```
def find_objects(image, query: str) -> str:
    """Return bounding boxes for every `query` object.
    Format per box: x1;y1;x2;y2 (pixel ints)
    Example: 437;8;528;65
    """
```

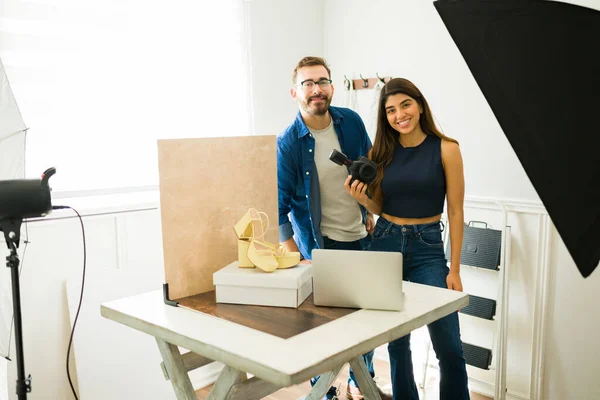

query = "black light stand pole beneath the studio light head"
0;218;31;400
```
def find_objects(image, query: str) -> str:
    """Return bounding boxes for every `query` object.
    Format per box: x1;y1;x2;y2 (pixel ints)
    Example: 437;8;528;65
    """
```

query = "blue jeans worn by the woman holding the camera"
368;217;469;400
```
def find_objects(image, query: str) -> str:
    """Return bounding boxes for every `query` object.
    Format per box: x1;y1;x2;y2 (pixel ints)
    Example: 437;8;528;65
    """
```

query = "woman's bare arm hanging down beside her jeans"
442;140;465;291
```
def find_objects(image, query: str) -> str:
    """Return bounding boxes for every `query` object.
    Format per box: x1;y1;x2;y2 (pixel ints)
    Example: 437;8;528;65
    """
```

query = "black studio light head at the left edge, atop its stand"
0;168;56;247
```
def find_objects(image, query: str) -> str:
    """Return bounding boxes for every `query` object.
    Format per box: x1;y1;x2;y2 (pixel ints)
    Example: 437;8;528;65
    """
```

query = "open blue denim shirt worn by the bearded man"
277;107;371;259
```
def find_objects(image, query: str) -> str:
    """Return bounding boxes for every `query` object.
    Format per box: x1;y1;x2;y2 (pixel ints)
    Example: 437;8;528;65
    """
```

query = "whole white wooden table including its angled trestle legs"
101;282;469;400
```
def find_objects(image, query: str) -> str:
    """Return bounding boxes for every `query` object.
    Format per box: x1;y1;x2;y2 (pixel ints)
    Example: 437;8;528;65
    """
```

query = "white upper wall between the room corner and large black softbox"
324;0;538;200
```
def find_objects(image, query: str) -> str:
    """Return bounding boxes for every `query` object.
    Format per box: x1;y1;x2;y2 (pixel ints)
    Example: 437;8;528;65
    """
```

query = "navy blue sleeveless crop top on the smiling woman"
381;135;446;218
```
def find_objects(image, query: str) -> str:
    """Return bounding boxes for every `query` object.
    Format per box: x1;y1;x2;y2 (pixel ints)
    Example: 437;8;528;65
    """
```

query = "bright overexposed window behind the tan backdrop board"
0;0;250;190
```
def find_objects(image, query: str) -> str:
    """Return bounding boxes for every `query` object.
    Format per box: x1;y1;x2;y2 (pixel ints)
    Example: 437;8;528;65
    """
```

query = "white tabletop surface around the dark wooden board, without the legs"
101;282;468;386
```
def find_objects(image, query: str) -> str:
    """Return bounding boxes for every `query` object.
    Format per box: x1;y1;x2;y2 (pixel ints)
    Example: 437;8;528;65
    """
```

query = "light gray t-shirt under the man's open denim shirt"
308;121;367;242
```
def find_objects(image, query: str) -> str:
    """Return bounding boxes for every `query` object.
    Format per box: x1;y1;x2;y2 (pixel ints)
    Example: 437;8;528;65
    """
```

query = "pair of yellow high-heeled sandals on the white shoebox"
233;208;300;272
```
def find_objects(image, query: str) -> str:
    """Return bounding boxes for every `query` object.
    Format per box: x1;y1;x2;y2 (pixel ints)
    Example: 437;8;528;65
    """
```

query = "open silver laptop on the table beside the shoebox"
312;249;404;311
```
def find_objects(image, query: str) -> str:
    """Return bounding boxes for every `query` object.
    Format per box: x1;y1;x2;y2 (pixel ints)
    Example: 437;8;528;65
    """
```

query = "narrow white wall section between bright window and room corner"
248;0;324;135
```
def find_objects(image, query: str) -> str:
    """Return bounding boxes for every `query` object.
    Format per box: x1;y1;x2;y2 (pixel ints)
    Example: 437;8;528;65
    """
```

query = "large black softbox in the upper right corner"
434;0;600;277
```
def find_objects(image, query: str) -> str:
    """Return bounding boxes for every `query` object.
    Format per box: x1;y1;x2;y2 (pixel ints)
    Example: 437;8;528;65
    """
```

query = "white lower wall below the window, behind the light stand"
0;201;164;399
